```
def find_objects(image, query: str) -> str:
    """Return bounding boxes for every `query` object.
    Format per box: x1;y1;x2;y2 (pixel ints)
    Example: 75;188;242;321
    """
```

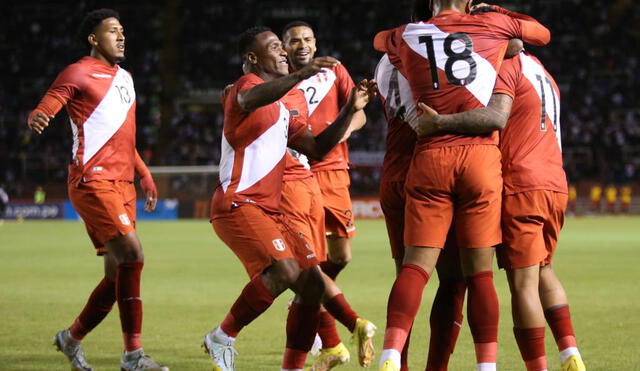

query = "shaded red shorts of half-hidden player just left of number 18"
380;182;405;260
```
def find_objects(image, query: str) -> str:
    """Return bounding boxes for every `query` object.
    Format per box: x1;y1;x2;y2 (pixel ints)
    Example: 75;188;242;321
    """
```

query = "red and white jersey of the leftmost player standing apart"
34;56;136;185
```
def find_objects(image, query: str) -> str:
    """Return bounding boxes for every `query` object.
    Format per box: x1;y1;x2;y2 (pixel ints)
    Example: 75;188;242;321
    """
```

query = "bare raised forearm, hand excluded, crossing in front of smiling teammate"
238;73;301;112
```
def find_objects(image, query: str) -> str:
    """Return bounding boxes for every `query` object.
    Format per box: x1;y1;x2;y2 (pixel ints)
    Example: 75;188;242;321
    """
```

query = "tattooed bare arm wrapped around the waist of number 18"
407;94;513;137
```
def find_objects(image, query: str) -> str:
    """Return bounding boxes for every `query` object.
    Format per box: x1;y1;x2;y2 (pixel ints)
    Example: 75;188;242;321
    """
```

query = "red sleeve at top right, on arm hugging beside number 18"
481;7;551;46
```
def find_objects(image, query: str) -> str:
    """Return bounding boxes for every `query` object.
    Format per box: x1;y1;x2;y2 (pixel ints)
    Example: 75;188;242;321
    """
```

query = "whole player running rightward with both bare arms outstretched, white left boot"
203;26;376;371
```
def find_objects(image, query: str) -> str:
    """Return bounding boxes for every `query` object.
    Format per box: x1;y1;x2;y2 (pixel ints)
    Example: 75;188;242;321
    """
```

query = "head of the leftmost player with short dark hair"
88;17;124;65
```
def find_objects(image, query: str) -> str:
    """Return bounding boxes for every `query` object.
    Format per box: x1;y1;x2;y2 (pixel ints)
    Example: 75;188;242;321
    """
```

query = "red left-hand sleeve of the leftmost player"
29;64;87;120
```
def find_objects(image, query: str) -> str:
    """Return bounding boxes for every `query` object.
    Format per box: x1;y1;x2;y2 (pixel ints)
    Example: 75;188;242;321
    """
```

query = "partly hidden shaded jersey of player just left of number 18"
375;54;416;182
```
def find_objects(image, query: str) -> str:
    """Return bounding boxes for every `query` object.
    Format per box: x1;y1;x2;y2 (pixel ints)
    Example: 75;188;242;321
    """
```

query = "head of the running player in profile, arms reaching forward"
245;31;289;81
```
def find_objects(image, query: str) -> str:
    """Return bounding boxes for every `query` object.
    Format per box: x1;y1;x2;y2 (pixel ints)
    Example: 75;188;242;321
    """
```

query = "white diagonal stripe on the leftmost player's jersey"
82;67;136;165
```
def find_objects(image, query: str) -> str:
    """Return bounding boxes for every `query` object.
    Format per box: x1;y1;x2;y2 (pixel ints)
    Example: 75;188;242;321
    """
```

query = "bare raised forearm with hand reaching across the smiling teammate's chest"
238;57;340;112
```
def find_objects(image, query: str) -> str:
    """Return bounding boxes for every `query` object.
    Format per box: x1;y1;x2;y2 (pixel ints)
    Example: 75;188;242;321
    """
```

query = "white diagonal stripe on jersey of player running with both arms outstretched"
236;102;289;192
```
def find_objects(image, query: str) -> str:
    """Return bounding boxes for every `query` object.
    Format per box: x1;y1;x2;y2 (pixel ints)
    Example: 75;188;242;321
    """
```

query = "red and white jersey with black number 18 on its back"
374;11;546;148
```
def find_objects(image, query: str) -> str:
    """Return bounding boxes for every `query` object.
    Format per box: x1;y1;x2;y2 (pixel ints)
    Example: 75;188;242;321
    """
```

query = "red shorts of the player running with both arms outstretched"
211;204;318;278
